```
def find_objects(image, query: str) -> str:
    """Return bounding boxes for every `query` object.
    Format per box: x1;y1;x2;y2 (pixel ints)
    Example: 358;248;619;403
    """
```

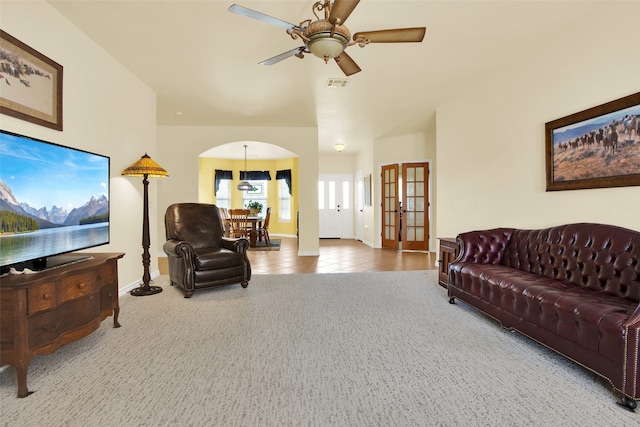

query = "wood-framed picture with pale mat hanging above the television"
0;30;63;131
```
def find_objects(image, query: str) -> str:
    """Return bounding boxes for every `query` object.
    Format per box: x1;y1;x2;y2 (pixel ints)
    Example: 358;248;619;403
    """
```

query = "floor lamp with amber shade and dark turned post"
122;153;169;296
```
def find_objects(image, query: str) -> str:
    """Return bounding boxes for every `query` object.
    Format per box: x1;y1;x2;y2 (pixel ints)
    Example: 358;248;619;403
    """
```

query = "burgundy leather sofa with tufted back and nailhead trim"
448;223;640;410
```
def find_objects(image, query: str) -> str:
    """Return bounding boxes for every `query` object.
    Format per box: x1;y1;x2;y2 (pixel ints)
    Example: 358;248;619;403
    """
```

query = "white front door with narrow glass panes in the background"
318;175;353;239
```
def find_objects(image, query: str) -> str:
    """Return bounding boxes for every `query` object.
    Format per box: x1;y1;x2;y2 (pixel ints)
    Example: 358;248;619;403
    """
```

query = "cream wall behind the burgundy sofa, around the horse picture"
436;2;640;237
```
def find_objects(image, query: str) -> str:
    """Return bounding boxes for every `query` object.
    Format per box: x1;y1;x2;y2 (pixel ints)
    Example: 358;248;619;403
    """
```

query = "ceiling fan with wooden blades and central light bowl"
229;0;426;76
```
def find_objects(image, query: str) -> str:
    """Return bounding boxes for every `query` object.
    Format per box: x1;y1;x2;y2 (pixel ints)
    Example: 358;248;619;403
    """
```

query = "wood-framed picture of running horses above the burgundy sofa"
545;92;640;191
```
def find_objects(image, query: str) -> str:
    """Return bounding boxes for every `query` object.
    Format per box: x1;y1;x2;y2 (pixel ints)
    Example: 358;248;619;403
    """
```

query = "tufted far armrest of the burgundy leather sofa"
453;228;514;264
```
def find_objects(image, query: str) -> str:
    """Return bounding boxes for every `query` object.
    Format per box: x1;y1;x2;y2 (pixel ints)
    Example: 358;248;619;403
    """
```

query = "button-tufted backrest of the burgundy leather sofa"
501;223;640;302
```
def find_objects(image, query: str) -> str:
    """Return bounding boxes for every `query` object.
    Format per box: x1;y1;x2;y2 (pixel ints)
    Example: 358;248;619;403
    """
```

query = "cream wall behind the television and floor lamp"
0;1;157;288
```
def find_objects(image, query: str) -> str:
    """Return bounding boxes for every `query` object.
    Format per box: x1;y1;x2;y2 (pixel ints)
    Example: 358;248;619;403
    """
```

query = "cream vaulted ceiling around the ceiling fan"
49;0;599;158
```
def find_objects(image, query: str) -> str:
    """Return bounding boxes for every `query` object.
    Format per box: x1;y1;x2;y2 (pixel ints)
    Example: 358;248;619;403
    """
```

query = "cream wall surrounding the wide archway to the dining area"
156;126;319;255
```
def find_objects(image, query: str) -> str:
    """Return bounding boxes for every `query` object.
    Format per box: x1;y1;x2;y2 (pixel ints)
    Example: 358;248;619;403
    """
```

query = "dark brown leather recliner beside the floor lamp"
163;203;251;298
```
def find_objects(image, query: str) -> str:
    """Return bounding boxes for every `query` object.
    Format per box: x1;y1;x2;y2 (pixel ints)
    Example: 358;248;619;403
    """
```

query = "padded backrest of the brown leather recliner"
164;203;223;249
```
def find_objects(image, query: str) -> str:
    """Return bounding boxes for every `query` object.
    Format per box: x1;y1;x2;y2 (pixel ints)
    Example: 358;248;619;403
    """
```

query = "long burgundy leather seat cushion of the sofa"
452;263;637;363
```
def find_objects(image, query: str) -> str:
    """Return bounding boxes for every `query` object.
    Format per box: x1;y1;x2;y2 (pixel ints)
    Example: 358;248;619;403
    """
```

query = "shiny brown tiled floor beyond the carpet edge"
158;236;437;274
